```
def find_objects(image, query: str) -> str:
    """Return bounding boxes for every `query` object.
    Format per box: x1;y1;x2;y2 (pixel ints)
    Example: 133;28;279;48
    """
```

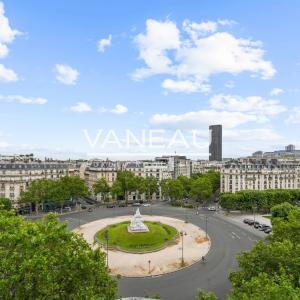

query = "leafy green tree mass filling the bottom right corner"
229;208;300;300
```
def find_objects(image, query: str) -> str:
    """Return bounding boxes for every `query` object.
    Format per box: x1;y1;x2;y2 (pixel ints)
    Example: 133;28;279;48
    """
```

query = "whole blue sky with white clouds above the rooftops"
0;0;300;158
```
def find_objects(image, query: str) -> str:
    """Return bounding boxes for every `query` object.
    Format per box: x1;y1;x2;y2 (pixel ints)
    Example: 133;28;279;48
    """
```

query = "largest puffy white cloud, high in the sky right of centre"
132;19;276;93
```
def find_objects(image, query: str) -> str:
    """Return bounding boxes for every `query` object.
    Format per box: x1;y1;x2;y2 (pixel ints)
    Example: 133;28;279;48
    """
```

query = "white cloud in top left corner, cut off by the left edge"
0;2;21;58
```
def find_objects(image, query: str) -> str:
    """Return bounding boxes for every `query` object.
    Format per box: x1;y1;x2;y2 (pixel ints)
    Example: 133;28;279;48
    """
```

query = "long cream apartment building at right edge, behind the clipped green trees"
221;158;300;193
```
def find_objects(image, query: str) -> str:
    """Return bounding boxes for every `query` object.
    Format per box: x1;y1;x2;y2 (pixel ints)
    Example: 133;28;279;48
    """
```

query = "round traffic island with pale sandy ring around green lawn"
74;211;210;277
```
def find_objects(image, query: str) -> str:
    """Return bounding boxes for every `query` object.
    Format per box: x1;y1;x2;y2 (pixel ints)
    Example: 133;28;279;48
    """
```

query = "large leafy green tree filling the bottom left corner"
0;211;116;300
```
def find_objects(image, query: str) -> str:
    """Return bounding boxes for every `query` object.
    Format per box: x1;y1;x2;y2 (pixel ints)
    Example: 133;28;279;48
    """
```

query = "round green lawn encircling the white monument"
96;221;177;253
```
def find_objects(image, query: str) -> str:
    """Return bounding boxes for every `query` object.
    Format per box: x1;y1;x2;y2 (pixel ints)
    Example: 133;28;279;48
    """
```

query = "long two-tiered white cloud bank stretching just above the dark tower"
150;94;286;129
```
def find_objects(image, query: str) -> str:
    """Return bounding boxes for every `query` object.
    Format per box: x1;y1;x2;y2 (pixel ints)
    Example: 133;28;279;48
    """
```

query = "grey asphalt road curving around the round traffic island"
60;205;263;300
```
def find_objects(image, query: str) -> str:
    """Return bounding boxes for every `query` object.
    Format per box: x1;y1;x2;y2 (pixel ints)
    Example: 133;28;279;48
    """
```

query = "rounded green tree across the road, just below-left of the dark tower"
190;177;213;203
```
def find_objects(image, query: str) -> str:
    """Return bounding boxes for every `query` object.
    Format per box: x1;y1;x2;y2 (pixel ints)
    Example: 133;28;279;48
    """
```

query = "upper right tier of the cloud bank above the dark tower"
209;94;286;116
